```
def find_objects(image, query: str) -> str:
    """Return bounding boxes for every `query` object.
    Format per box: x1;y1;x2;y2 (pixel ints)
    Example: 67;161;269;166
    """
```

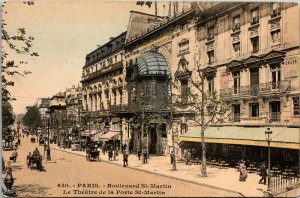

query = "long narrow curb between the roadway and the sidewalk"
52;148;246;197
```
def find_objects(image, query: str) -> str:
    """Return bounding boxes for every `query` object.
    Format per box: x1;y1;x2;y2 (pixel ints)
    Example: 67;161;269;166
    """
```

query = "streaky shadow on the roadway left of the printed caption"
14;184;50;197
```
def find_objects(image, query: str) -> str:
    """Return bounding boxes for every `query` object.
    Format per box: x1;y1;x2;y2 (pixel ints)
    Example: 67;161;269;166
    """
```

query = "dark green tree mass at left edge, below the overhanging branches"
2;101;15;132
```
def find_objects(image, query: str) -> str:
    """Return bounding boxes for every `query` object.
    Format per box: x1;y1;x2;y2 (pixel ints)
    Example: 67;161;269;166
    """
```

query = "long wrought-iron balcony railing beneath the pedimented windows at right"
220;80;291;98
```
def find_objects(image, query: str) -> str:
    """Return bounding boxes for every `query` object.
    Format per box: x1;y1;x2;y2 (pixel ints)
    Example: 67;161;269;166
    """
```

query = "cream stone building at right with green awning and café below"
179;2;300;167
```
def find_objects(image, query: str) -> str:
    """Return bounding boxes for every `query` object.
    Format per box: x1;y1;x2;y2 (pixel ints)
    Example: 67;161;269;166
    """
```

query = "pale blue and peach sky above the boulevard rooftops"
2;0;177;114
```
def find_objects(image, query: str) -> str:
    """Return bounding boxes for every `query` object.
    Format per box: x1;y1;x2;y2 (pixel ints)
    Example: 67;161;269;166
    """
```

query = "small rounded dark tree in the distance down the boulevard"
23;105;43;129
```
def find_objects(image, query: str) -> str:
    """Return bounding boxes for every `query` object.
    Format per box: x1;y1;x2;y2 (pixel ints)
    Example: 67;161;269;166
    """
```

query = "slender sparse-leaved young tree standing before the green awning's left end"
174;65;231;177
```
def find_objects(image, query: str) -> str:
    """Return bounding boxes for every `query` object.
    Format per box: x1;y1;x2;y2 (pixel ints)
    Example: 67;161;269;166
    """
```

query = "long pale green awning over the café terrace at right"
179;126;300;149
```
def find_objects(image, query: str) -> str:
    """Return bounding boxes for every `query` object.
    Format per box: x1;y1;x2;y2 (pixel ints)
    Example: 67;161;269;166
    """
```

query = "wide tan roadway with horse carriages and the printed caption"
3;137;240;197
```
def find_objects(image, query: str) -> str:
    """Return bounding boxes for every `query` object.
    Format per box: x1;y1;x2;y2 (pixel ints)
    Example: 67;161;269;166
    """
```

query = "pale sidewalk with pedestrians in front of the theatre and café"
52;146;267;197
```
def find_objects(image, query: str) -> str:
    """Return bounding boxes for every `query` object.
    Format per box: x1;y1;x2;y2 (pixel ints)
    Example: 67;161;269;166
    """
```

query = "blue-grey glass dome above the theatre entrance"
137;51;168;75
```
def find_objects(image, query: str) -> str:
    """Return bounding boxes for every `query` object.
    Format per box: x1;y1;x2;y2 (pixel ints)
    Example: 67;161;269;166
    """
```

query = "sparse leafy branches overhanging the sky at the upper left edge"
1;1;39;101
